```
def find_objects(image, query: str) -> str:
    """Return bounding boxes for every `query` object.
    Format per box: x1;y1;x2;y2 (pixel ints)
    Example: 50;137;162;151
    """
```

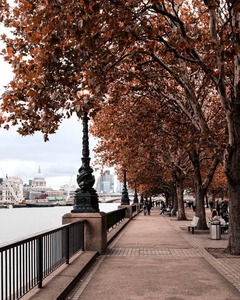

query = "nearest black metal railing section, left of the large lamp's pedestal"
0;221;84;300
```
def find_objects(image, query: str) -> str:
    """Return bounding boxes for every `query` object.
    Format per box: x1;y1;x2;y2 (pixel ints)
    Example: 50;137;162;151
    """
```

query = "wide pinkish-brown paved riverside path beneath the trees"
66;208;240;300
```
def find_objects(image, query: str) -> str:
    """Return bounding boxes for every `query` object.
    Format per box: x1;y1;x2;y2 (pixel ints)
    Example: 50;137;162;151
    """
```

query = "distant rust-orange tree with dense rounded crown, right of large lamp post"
92;77;218;223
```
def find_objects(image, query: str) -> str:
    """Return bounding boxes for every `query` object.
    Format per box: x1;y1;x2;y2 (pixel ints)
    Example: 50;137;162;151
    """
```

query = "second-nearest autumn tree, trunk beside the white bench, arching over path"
91;34;224;229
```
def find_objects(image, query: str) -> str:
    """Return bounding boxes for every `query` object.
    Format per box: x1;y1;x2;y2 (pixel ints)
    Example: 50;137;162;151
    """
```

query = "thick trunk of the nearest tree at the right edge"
224;2;240;255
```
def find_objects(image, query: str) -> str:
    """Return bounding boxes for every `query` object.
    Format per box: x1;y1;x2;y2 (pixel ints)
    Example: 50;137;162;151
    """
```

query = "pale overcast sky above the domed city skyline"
0;35;98;189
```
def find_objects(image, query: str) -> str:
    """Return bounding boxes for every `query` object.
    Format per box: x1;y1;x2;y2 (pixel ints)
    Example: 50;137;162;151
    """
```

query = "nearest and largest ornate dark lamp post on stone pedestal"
71;112;99;213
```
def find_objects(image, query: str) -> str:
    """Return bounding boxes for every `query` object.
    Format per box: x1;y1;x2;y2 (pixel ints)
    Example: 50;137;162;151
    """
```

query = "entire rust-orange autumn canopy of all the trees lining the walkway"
0;0;240;253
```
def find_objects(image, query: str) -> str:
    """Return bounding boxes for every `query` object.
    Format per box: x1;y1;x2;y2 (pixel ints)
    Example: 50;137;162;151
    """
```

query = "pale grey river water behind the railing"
0;203;119;246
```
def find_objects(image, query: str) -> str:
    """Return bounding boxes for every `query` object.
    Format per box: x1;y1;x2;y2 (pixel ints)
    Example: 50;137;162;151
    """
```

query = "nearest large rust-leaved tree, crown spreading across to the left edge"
0;0;240;254
